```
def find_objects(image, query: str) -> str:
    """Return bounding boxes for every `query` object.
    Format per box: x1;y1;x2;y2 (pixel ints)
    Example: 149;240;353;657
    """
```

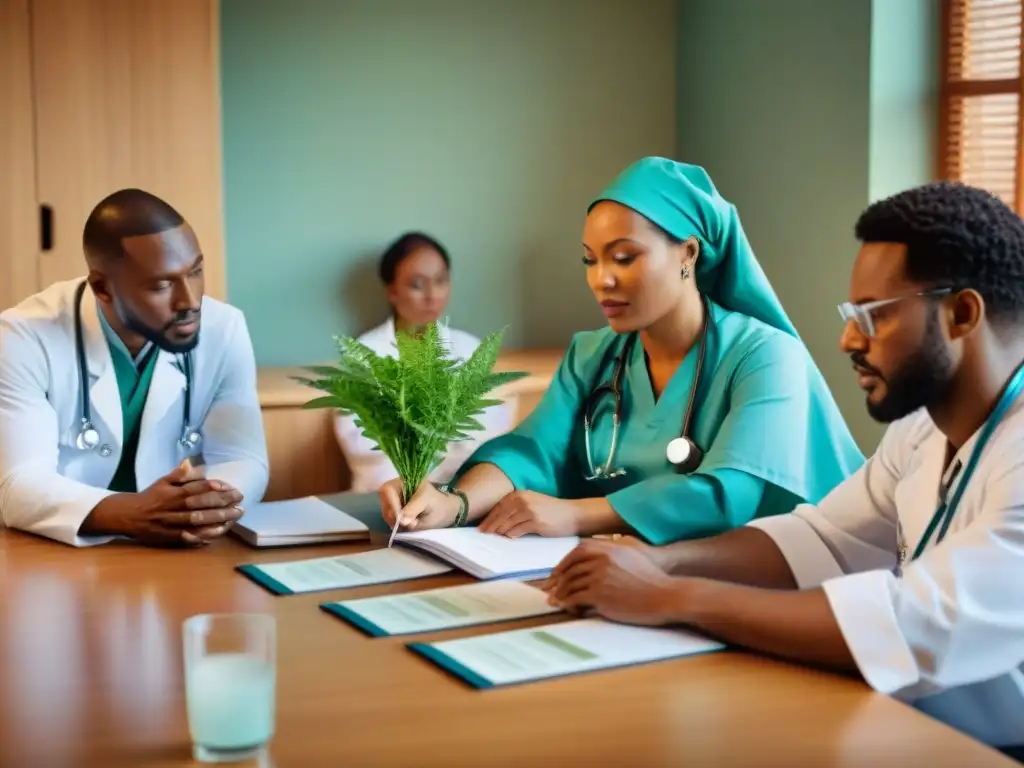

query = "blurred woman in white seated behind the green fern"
334;231;516;493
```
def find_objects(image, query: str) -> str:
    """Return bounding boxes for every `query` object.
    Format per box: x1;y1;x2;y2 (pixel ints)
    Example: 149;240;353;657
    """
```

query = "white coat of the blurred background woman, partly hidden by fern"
334;317;517;493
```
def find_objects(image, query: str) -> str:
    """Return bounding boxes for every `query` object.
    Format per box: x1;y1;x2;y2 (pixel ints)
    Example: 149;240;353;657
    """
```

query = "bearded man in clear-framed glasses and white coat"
546;182;1024;756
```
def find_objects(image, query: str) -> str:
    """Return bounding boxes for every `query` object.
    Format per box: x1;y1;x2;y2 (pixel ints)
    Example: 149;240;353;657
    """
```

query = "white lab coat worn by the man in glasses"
750;398;1024;746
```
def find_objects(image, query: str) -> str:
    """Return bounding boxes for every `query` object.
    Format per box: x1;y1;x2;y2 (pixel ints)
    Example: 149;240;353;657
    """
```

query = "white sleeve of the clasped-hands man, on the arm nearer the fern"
197;312;270;507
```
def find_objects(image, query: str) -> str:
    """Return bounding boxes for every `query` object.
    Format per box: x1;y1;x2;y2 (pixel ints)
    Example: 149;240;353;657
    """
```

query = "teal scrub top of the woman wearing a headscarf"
460;302;864;545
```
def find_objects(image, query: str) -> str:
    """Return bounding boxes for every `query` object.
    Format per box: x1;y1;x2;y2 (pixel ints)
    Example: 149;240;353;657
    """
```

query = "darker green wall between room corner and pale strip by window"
678;0;876;447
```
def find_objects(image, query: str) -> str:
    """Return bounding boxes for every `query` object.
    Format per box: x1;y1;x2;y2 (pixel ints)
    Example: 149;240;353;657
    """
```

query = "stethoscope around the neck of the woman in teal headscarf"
583;296;712;480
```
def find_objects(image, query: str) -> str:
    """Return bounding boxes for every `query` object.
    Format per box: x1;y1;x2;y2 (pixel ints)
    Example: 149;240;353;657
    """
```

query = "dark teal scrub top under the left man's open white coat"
96;307;158;494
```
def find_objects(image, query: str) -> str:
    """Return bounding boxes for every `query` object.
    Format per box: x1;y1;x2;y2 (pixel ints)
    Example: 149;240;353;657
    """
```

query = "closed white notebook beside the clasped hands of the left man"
231;496;370;547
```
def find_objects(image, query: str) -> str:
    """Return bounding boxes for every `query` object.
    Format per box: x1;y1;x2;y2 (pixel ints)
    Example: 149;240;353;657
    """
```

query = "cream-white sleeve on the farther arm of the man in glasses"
748;422;906;589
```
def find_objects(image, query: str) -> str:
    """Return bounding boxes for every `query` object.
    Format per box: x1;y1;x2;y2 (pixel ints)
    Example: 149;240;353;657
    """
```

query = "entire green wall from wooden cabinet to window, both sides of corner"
221;0;939;450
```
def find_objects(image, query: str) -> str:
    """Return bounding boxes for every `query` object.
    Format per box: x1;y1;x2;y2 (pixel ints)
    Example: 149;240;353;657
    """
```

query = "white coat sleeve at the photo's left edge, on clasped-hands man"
0;316;115;547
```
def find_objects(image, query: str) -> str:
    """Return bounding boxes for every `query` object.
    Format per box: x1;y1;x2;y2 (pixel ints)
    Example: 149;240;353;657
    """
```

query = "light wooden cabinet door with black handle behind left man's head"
32;0;225;298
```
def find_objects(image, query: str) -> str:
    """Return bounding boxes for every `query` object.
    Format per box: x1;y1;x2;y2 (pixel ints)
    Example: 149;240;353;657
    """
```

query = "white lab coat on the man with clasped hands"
0;280;268;547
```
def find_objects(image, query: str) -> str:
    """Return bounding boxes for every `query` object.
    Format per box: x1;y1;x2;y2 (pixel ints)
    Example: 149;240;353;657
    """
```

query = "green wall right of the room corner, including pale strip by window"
677;0;939;452
